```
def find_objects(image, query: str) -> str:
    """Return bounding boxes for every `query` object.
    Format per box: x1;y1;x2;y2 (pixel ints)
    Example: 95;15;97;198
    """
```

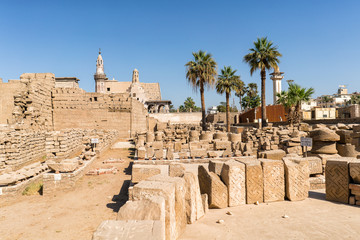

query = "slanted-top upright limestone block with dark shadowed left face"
198;165;228;208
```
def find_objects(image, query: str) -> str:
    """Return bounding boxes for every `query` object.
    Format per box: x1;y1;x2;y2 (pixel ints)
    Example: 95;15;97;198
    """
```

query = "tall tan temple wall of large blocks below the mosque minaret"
53;88;147;137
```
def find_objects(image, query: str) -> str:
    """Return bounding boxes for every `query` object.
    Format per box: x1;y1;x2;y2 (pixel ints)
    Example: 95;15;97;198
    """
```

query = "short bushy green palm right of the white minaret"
277;83;315;125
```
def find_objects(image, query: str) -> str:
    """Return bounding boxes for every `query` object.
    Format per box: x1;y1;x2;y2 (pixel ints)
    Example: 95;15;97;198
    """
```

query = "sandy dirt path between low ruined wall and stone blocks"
0;142;131;240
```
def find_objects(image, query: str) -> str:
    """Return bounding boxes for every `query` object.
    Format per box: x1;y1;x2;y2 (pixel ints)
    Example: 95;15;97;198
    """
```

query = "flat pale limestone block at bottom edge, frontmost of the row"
92;220;165;240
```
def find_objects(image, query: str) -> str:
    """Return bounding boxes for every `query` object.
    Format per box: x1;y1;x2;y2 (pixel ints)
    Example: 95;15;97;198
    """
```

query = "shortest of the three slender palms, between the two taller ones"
216;66;242;132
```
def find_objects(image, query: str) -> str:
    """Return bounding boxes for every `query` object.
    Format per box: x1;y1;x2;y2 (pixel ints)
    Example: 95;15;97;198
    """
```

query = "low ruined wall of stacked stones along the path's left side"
0;129;118;174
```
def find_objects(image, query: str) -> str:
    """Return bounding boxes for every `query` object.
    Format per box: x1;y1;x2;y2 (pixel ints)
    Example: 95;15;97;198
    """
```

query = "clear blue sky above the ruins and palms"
0;0;360;107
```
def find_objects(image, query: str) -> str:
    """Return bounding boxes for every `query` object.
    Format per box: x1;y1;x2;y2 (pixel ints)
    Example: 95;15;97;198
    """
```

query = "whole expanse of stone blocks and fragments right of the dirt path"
93;124;360;239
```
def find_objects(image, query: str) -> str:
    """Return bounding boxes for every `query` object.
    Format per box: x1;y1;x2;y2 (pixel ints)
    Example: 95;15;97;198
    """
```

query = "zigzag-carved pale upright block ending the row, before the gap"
284;159;310;201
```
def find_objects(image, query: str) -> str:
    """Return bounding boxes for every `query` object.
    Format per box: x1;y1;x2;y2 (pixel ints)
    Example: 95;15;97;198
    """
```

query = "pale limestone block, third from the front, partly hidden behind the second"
133;181;177;240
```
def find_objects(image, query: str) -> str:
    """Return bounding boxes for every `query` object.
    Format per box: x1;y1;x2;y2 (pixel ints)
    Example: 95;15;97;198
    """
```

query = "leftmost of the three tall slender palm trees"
185;50;217;130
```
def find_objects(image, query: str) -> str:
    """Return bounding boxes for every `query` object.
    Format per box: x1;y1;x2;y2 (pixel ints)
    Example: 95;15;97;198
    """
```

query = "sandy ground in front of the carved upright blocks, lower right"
180;191;360;240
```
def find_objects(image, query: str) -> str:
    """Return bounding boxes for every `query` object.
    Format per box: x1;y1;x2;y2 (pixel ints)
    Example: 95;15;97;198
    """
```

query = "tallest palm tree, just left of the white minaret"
244;37;282;127
